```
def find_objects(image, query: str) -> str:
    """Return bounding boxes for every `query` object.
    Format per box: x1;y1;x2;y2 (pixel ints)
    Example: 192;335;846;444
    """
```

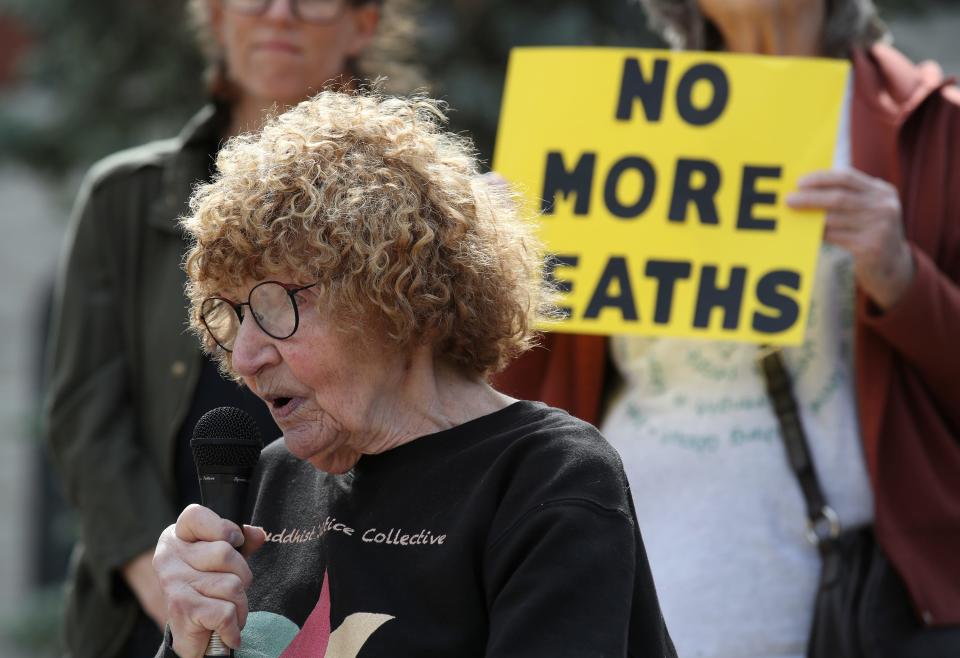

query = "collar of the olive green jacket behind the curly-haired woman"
148;104;230;235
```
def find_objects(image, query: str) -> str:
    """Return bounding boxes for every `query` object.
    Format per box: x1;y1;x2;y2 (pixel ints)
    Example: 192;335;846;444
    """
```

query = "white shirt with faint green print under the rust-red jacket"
602;77;873;658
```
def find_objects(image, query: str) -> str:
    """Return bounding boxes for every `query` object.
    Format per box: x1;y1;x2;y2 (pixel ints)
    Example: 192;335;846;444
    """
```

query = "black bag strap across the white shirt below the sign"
759;346;840;546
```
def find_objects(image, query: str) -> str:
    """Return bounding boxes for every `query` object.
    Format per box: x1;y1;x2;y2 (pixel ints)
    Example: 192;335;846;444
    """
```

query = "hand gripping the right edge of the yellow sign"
787;169;914;309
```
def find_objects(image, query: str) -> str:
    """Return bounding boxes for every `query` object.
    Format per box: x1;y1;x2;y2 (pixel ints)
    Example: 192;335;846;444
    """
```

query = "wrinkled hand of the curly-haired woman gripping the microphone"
153;505;266;658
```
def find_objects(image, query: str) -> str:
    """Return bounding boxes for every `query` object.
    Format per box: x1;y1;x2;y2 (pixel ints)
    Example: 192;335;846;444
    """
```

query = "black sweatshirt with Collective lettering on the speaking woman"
159;402;675;658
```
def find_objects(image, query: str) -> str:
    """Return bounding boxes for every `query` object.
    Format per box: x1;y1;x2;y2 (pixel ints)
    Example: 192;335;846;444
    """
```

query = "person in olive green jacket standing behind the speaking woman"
48;0;420;657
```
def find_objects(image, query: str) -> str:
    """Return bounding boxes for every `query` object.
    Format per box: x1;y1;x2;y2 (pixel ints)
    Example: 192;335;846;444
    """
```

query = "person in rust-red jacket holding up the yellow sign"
499;0;960;658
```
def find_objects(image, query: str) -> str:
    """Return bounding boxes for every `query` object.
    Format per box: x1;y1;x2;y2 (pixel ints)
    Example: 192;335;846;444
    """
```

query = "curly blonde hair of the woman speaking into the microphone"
181;90;550;376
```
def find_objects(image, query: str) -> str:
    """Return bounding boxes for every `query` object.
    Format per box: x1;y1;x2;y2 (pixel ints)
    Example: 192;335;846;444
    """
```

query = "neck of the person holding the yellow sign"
708;2;825;57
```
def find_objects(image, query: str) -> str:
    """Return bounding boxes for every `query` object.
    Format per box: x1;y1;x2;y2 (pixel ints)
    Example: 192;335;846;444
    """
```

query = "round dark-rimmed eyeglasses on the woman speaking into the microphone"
200;281;317;352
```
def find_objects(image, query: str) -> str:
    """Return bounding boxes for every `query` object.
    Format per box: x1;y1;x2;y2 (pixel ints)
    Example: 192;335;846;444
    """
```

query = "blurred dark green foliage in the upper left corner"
0;0;203;173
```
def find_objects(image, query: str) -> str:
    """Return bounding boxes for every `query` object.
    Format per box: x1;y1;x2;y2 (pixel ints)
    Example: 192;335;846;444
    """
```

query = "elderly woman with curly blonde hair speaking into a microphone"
154;92;674;658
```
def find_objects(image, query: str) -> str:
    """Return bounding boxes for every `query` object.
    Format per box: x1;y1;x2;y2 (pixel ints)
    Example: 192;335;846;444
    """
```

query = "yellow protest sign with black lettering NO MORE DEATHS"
494;48;849;345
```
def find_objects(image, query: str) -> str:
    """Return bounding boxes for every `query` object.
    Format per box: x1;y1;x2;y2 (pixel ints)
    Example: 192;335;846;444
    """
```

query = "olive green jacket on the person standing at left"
46;106;225;658
